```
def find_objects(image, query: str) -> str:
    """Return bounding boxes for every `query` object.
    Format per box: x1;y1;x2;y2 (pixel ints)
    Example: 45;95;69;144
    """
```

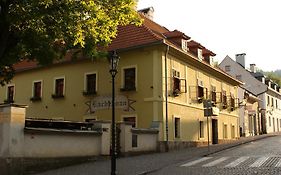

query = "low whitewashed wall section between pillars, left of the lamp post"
24;132;101;158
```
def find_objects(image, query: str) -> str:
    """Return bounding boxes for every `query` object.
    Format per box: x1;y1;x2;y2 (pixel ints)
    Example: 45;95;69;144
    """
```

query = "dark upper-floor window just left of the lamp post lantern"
83;73;97;96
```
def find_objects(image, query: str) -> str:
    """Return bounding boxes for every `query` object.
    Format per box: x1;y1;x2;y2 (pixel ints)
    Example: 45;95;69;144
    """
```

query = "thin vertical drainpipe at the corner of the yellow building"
165;45;170;152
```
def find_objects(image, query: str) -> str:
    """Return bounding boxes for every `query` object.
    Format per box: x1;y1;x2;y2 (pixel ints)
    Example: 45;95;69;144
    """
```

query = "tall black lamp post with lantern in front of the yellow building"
109;51;120;175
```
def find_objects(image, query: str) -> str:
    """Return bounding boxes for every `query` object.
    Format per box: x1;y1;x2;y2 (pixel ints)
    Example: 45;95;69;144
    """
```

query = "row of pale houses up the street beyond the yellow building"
219;54;281;136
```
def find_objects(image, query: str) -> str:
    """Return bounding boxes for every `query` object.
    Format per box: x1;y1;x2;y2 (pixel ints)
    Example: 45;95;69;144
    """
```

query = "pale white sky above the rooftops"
138;0;281;71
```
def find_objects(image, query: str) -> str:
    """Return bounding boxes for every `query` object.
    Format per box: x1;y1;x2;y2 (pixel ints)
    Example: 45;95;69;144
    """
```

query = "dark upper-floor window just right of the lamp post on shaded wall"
121;68;136;91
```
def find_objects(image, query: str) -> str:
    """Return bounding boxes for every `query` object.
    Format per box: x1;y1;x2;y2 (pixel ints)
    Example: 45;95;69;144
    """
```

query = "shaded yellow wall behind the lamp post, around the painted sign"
0;49;161;128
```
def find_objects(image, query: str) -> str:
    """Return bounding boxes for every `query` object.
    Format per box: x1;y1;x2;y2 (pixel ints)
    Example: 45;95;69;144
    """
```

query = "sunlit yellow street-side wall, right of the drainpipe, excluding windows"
162;49;239;142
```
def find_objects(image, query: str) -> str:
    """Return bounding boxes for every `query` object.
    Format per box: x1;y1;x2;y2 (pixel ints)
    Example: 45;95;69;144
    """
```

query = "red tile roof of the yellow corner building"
14;14;214;71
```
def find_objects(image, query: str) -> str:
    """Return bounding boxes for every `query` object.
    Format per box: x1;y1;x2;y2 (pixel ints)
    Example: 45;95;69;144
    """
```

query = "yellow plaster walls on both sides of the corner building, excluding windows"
0;46;239;142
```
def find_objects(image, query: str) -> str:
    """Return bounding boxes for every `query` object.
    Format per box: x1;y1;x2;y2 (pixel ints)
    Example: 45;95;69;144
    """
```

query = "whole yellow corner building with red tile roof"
0;11;240;147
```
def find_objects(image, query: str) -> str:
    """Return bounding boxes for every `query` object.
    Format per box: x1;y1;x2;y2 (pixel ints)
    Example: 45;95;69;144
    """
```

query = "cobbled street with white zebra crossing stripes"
150;136;281;175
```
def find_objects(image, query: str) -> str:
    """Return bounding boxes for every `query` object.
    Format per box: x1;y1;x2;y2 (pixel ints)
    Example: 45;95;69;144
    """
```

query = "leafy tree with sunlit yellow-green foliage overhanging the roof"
0;0;141;85
